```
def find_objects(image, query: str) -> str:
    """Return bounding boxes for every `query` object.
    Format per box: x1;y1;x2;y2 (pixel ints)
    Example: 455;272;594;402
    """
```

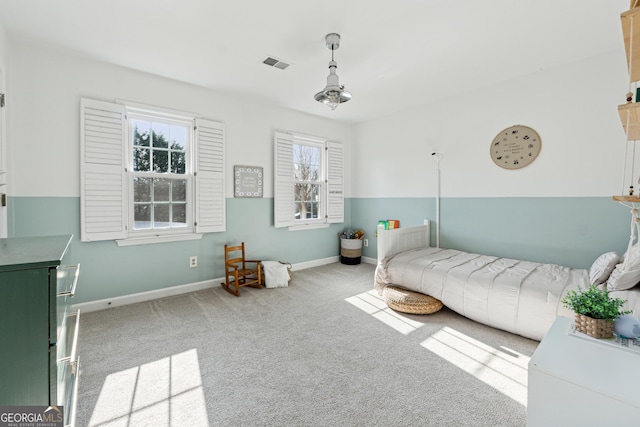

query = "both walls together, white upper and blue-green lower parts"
7;41;629;308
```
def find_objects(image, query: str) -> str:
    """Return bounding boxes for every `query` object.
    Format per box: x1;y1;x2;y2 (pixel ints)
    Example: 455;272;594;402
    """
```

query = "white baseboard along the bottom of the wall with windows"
73;256;340;313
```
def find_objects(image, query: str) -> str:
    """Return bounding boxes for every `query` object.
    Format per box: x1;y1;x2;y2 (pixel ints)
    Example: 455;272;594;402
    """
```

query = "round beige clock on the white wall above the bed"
490;125;542;169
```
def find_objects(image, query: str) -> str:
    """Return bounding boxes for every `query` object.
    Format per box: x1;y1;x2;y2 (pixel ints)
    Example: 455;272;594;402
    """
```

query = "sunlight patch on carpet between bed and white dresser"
421;326;530;406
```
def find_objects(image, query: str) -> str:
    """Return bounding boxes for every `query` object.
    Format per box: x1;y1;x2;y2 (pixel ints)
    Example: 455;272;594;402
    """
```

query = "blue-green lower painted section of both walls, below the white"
9;197;630;303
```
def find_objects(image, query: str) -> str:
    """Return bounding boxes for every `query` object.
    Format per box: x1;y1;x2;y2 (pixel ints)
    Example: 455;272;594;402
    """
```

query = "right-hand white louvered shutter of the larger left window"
195;119;226;233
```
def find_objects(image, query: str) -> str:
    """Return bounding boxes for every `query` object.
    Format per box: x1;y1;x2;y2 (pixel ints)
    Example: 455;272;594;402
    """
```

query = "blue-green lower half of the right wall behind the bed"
351;197;630;268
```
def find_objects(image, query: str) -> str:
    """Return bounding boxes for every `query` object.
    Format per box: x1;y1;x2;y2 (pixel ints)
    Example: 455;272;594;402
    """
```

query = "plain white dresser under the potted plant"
527;317;640;427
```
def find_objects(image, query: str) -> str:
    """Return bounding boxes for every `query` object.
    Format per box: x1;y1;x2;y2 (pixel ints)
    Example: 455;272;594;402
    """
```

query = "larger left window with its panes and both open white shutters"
81;99;226;245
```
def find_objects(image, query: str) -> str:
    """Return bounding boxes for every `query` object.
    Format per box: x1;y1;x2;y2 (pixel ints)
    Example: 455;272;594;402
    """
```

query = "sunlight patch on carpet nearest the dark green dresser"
89;349;209;427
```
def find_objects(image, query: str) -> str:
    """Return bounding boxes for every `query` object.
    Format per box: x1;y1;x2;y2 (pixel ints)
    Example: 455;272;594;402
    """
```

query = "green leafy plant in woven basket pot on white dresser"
562;285;631;338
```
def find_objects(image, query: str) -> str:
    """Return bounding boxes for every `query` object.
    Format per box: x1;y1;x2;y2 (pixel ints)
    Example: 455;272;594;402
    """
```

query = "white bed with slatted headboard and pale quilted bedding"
375;221;640;340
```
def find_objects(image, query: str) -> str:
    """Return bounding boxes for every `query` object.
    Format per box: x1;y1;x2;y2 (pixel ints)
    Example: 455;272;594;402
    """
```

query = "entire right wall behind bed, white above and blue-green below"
344;51;638;274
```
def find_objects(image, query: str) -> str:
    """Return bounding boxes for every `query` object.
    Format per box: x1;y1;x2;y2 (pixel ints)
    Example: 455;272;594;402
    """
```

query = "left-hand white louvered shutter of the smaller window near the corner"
273;132;294;228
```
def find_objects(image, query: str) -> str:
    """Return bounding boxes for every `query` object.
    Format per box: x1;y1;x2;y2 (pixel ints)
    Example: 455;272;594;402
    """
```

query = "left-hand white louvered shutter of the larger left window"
80;99;128;242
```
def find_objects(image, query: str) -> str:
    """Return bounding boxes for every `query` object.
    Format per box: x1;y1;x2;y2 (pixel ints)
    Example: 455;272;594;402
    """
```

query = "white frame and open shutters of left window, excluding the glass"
80;98;226;246
